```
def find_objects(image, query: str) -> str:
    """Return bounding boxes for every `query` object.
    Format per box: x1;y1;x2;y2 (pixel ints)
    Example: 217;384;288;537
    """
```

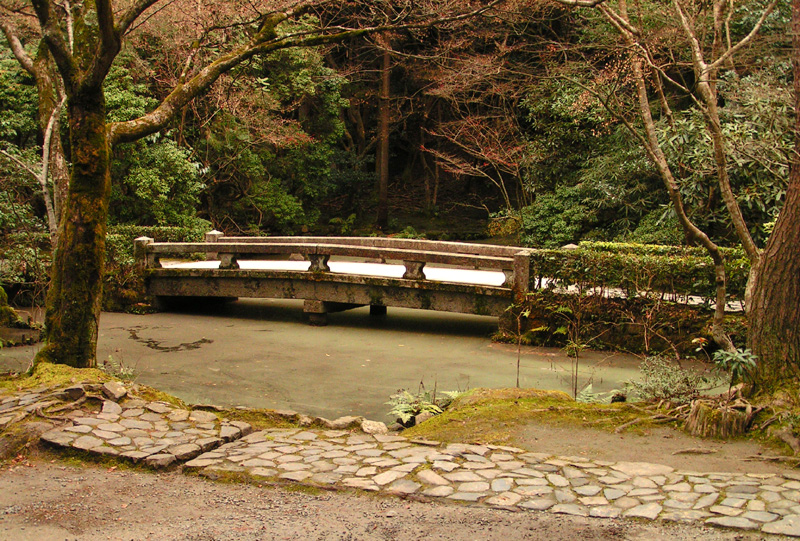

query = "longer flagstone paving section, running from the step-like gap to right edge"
184;429;800;536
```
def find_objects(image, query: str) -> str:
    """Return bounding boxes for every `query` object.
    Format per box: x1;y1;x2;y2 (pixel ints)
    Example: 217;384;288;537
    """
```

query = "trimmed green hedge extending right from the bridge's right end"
530;242;750;301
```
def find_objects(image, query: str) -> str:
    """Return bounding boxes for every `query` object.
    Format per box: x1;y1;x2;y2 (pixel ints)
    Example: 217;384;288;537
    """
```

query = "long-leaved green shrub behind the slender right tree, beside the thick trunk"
659;69;794;242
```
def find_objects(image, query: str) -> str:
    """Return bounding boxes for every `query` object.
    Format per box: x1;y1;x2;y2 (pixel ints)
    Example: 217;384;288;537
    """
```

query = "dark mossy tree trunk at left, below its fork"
36;89;111;368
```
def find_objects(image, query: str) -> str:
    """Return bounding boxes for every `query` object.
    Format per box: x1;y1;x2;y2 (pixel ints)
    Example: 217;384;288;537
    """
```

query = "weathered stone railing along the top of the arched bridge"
134;231;530;297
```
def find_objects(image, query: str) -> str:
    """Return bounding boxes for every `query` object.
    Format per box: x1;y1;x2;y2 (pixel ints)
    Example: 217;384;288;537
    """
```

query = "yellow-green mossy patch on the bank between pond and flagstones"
403;389;664;445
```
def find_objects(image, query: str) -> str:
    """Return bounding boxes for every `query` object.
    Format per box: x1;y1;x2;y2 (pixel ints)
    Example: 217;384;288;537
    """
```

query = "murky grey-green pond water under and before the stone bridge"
0;299;656;421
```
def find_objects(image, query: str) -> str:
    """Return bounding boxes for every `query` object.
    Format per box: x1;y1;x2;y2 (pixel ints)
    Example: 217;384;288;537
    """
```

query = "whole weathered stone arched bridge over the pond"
135;231;530;325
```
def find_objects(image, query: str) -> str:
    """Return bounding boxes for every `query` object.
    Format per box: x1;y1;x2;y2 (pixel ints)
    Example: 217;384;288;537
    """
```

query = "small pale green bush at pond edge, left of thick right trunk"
630;356;721;404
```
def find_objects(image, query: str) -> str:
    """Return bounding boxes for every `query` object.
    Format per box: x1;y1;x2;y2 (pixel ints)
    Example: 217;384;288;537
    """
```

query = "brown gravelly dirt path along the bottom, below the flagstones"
0;455;776;541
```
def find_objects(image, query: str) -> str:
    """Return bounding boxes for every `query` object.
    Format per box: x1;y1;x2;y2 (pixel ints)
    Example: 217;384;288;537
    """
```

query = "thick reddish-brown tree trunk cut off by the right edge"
747;0;800;391
